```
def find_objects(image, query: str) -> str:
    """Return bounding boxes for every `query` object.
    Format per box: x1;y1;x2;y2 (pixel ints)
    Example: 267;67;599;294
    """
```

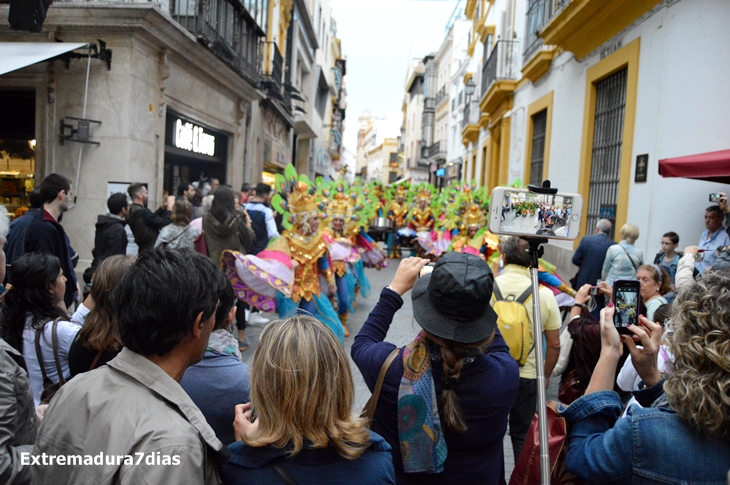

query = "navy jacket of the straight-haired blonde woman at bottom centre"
220;431;395;485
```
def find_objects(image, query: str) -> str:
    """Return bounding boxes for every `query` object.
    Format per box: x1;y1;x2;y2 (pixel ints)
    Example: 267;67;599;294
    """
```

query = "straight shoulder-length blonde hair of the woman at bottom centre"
243;315;370;460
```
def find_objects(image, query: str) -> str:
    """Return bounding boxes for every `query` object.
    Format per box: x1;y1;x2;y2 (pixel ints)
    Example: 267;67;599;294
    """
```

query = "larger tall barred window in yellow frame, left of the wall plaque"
586;69;628;237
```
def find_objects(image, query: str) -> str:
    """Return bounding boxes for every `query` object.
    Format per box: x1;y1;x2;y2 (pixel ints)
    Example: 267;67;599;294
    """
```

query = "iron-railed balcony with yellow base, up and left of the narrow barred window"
480;40;519;114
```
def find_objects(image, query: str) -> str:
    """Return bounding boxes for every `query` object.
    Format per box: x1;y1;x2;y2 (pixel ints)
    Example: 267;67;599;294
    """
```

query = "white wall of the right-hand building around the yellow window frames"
510;0;730;259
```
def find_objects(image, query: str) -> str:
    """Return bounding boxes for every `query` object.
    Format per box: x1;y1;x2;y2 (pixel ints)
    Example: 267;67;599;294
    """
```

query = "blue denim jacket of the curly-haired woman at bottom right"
562;382;730;485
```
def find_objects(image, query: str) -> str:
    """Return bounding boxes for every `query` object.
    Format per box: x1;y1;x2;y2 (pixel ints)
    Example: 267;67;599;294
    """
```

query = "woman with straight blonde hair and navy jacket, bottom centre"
221;316;395;485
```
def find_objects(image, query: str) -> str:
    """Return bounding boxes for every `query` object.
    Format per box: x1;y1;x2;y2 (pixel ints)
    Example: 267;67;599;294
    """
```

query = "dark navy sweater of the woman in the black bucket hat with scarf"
352;289;520;485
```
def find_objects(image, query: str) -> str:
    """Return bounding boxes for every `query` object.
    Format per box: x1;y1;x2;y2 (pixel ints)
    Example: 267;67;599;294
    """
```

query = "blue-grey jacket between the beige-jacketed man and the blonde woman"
180;350;251;446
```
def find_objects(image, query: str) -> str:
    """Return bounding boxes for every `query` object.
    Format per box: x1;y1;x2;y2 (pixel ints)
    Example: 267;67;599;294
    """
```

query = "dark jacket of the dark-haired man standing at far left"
5;209;76;307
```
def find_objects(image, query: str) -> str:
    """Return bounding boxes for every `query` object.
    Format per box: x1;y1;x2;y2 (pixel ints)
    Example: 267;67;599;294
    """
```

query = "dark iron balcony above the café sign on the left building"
168;0;264;82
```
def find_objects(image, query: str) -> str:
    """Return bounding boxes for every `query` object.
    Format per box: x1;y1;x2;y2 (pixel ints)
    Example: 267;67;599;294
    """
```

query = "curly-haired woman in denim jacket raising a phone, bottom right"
563;271;730;484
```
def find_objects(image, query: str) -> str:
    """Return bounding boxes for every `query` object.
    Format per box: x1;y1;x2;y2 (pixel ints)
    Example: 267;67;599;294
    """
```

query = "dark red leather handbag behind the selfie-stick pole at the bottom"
509;406;584;485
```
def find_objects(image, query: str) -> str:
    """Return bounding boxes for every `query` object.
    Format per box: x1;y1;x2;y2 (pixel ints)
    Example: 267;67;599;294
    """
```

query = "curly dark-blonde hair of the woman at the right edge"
664;271;730;438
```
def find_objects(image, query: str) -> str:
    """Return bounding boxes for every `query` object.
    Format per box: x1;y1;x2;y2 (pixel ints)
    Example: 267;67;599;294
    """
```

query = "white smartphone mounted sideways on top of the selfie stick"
499;190;579;239
